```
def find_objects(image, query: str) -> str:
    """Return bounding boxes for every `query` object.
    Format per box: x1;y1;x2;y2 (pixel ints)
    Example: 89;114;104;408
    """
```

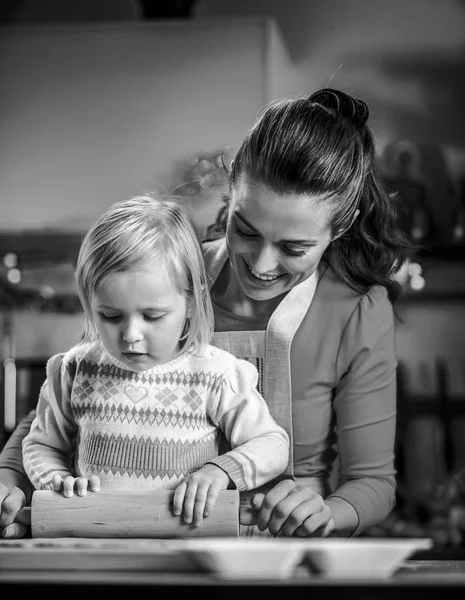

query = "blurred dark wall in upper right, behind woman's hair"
195;0;465;155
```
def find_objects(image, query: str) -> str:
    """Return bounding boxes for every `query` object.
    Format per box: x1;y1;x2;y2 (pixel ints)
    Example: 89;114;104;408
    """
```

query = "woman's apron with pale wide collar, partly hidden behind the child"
206;240;327;537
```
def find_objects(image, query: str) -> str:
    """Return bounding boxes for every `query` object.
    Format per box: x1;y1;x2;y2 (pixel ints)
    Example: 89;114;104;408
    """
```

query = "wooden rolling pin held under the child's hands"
16;490;239;538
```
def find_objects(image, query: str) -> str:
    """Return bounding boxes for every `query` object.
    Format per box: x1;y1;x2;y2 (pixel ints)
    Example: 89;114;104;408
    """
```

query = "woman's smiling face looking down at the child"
226;178;331;301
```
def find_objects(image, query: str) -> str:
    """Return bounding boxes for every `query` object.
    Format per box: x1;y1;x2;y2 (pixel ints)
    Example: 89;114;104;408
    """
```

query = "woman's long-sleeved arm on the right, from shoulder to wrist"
326;287;397;535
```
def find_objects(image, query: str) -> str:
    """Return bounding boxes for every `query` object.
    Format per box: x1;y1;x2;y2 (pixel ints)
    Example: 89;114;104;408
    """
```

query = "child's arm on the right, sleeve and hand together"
169;360;289;527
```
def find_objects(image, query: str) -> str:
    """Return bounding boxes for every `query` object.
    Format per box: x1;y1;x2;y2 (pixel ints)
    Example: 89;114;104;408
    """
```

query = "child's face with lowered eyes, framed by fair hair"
92;262;188;372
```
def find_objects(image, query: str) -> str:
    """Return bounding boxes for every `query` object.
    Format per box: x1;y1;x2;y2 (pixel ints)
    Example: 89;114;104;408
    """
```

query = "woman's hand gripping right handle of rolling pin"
240;479;334;537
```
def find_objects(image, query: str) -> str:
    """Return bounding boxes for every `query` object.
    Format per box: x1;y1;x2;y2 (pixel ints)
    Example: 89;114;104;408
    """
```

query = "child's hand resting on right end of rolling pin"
173;464;230;527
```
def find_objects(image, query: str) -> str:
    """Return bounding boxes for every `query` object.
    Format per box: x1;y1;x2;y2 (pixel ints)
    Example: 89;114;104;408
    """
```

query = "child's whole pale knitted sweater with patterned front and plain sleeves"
23;342;289;490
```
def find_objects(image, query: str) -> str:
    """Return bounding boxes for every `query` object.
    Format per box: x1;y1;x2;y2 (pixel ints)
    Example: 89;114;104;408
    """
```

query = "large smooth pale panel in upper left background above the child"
0;17;292;230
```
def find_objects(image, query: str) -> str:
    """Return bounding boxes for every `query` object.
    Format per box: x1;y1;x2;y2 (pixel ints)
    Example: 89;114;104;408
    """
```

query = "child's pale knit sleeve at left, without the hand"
22;354;77;489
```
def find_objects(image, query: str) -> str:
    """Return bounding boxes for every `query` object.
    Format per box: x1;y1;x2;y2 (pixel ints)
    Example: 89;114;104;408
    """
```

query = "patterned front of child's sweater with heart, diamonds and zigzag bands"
69;352;224;488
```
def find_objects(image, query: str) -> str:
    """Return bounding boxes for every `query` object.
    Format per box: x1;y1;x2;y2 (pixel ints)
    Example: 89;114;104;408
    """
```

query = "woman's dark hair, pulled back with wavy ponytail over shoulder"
207;89;413;301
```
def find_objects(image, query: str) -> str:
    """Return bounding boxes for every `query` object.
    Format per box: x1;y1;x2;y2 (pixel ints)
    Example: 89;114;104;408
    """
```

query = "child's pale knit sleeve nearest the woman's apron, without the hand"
208;359;290;491
